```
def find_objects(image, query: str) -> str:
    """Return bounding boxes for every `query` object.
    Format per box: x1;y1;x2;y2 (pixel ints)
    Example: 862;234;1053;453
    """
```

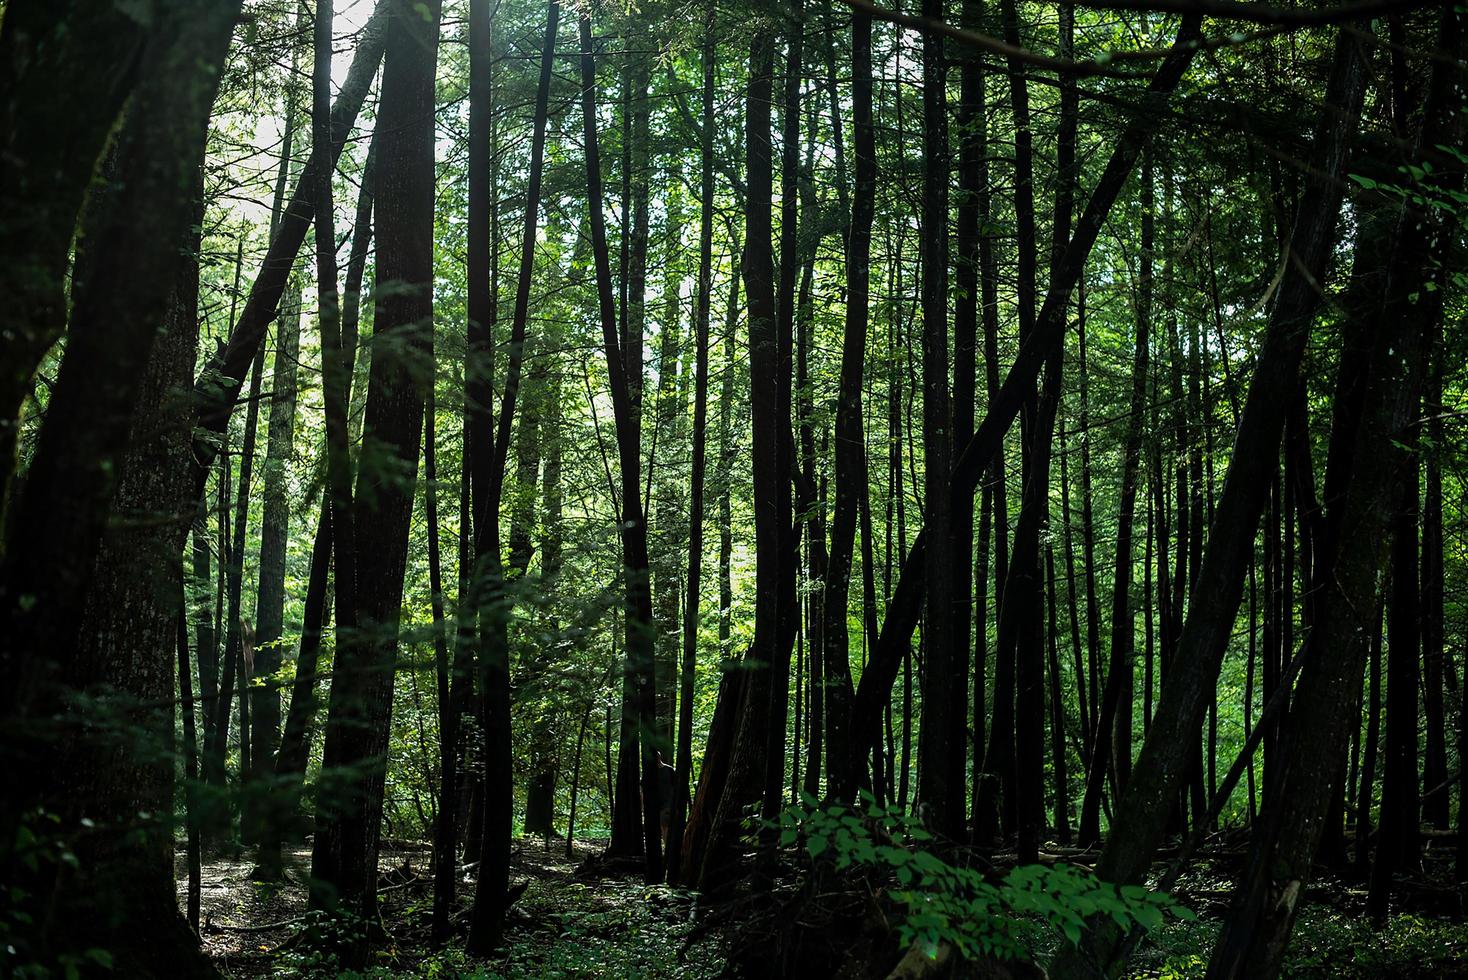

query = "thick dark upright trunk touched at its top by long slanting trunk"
311;0;439;968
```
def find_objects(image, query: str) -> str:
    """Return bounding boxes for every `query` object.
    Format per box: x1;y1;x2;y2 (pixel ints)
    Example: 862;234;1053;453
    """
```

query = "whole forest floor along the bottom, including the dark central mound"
179;838;1468;980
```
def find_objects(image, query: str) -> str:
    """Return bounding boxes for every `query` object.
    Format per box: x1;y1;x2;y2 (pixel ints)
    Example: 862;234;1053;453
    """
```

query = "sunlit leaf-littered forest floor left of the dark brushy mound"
179;838;724;980
